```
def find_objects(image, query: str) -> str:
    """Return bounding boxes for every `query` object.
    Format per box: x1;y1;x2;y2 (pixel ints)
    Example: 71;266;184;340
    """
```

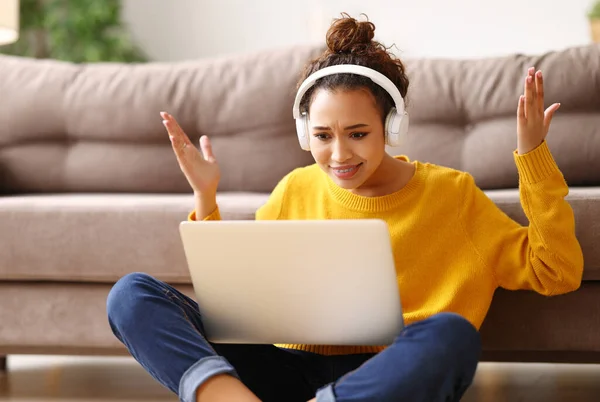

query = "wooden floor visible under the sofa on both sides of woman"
0;356;600;402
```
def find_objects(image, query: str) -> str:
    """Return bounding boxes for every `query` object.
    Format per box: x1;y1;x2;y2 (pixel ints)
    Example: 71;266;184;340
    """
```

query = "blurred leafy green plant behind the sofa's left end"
0;0;146;63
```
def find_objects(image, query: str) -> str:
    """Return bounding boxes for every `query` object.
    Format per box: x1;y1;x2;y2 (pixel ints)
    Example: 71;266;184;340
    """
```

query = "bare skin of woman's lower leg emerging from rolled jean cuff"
196;374;260;402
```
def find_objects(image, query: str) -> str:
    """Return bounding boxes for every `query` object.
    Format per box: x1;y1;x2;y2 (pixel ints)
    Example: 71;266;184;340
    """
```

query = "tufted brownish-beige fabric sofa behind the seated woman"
0;45;600;362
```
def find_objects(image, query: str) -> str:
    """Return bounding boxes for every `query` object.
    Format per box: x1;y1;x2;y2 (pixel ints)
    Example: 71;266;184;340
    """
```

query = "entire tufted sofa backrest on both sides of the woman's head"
0;45;600;193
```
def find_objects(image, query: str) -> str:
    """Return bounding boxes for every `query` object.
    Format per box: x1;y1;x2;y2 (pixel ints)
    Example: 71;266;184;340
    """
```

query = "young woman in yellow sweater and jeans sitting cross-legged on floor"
107;16;583;402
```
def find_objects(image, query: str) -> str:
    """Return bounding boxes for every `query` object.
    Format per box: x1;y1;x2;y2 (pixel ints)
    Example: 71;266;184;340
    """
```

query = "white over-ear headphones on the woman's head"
293;64;409;151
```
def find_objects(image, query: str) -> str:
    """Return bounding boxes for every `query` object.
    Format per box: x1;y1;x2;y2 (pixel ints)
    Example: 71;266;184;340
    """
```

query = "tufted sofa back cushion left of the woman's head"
0;46;319;193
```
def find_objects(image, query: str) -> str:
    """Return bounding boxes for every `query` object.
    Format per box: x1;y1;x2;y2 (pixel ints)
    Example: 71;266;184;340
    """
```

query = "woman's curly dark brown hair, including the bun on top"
297;13;408;121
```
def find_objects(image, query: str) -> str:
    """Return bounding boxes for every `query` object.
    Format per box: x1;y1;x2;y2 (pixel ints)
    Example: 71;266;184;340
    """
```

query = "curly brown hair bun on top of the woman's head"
326;13;375;53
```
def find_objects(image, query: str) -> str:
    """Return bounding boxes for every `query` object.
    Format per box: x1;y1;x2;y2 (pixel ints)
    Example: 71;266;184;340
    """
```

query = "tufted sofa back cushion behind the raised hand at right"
389;44;600;189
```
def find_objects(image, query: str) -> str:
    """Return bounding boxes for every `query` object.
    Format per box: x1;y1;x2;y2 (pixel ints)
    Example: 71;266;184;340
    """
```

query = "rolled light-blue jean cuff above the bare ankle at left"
179;356;240;402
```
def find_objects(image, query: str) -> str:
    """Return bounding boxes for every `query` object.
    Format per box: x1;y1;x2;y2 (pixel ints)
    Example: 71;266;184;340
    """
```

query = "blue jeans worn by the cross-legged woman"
107;273;481;402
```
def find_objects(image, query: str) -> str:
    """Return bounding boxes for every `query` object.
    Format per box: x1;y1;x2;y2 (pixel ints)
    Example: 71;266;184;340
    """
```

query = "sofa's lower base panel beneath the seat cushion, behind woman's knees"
0;282;600;356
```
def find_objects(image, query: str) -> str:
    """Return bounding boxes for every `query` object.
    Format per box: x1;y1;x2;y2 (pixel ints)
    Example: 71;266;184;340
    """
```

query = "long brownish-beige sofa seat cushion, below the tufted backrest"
0;187;600;283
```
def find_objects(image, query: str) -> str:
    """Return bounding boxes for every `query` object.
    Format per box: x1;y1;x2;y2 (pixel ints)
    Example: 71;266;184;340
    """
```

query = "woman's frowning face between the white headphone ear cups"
308;88;386;190
